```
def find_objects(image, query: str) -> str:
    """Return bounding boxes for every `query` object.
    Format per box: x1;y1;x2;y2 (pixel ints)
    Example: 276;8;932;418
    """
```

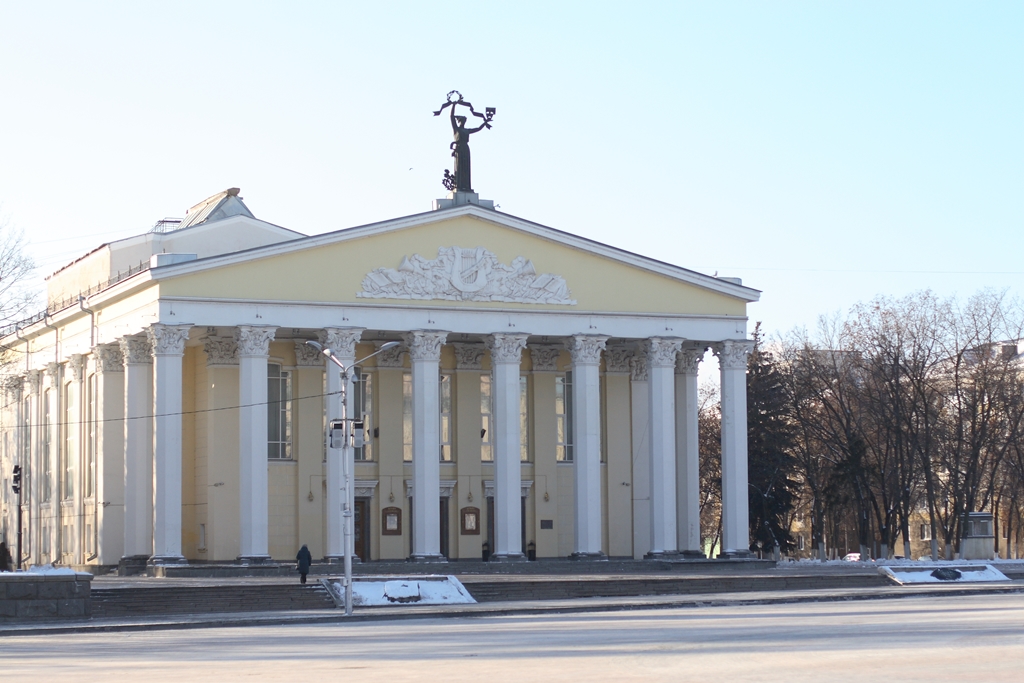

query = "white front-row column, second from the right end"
643;337;682;558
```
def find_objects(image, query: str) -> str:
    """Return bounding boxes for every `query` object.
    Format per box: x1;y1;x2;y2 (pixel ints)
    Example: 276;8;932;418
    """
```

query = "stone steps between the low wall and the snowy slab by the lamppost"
90;582;335;618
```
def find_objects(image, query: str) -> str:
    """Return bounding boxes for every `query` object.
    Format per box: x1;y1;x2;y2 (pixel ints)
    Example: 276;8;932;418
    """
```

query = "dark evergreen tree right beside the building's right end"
746;323;798;553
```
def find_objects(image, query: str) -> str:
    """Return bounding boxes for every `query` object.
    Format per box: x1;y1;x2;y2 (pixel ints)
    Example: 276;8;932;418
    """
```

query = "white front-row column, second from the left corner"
234;325;276;563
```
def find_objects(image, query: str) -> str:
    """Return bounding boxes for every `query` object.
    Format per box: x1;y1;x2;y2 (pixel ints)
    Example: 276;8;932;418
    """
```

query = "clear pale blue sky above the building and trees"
0;0;1024;331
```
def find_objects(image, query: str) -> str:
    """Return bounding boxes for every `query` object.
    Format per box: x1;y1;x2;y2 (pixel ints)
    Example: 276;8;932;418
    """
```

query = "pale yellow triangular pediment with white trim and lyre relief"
152;207;758;315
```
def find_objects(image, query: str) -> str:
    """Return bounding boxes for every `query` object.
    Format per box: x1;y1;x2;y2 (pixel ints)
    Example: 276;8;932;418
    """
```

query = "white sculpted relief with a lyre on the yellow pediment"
355;247;577;306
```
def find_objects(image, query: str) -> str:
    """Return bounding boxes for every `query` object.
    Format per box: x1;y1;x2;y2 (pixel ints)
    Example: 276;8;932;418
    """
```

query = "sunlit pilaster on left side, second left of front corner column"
93;344;125;564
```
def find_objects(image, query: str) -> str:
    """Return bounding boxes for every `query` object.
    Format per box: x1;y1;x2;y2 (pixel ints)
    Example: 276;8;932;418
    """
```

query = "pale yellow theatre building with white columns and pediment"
0;189;758;565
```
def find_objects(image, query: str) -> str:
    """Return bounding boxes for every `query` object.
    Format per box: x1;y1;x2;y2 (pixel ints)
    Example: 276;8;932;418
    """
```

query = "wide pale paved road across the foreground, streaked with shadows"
0;594;1024;683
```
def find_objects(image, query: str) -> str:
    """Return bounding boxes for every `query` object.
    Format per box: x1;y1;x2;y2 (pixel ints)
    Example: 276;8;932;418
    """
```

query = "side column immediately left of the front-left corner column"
120;336;153;565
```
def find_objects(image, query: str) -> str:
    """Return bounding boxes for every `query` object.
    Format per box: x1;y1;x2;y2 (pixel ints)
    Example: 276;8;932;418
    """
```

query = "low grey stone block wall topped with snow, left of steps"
0;571;92;623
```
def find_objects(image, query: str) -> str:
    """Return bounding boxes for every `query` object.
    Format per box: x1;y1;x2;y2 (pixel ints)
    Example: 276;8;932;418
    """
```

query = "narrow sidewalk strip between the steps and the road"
0;581;1024;637
